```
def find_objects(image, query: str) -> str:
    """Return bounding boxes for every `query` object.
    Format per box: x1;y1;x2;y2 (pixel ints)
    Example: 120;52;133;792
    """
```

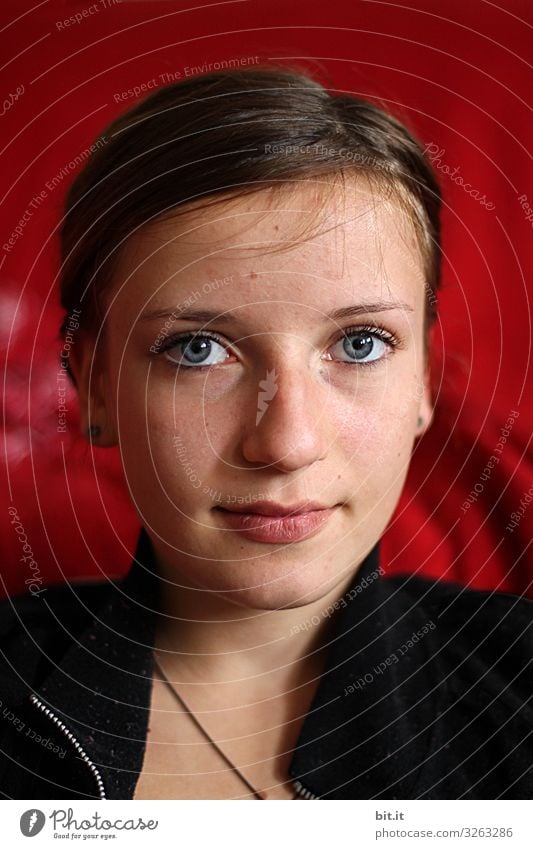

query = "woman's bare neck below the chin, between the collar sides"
155;565;362;693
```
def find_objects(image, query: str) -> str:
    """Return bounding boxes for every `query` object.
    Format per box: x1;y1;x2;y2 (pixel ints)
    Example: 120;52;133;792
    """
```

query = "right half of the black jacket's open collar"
289;546;446;799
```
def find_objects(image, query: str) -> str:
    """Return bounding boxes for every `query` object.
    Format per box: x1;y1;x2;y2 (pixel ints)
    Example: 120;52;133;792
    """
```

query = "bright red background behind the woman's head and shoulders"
0;0;533;597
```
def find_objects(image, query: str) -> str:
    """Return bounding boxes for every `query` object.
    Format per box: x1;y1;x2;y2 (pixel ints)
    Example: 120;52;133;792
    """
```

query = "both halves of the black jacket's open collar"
31;530;442;799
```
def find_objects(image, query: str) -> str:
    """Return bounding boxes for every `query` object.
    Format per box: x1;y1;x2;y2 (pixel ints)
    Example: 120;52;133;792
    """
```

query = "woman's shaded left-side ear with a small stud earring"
69;333;118;448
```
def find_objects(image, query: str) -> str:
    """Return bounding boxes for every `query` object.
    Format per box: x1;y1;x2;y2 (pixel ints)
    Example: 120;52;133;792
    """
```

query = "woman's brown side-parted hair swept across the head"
60;65;441;377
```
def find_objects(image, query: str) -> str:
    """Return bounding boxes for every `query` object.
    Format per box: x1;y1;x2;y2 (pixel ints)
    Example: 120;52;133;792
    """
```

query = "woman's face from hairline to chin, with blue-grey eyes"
82;182;431;610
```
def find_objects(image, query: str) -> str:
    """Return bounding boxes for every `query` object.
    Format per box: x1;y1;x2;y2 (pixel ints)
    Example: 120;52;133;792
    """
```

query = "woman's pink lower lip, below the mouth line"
216;504;340;543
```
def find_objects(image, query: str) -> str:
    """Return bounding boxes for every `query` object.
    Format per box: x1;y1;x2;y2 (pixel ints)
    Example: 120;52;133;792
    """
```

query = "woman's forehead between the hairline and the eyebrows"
108;179;424;317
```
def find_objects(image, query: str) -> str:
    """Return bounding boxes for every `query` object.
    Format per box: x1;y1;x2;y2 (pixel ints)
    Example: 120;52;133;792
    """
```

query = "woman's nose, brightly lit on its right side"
242;363;329;472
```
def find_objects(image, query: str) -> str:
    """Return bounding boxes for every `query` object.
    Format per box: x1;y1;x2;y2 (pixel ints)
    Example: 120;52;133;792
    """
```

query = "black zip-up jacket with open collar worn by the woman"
0;531;533;799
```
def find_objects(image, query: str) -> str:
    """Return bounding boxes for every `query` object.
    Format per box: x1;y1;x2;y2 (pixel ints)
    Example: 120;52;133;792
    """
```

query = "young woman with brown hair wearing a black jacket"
0;66;533;800
